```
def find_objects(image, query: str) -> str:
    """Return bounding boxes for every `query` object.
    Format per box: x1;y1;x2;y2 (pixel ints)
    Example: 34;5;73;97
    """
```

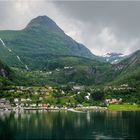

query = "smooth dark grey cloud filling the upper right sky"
55;1;140;37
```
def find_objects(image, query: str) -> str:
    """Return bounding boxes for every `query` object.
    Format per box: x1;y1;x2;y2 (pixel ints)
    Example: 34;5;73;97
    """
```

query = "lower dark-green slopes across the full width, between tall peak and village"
0;51;140;87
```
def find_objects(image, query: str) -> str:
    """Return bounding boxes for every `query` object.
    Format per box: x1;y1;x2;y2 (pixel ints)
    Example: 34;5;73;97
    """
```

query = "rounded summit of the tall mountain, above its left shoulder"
26;15;57;28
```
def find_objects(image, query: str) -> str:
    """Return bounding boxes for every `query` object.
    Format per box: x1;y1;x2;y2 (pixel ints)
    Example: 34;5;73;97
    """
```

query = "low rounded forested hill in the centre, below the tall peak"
11;56;115;85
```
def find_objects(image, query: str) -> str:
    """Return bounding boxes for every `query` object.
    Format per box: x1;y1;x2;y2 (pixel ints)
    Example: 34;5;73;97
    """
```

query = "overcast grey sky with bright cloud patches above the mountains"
0;0;140;55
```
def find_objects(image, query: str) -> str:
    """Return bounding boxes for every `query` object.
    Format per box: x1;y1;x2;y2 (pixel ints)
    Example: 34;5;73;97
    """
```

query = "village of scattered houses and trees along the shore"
0;84;131;110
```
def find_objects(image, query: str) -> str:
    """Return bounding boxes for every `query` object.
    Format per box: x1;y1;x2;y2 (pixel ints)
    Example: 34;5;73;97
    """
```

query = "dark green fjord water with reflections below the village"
0;111;140;140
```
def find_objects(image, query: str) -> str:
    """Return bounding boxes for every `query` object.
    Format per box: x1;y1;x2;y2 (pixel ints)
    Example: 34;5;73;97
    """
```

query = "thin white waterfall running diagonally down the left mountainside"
0;38;29;70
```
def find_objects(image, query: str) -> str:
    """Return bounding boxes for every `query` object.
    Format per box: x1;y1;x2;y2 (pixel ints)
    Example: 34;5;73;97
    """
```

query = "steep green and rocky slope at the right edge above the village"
111;50;140;87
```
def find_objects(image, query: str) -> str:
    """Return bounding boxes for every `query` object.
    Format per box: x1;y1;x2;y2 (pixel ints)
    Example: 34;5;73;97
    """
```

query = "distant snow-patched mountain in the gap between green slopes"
102;52;126;64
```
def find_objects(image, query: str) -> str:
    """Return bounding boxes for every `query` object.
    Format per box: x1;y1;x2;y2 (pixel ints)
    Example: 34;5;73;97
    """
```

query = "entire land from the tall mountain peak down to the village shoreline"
0;16;140;110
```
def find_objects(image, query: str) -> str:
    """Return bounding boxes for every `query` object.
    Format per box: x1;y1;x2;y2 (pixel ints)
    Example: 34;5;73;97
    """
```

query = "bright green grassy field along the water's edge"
108;104;140;111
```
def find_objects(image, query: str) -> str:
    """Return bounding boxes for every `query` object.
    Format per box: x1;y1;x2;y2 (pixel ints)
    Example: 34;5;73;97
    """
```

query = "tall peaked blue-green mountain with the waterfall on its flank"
0;16;96;69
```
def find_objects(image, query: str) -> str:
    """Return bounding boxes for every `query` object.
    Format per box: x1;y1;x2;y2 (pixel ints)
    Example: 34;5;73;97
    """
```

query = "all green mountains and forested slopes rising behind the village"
0;16;140;85
